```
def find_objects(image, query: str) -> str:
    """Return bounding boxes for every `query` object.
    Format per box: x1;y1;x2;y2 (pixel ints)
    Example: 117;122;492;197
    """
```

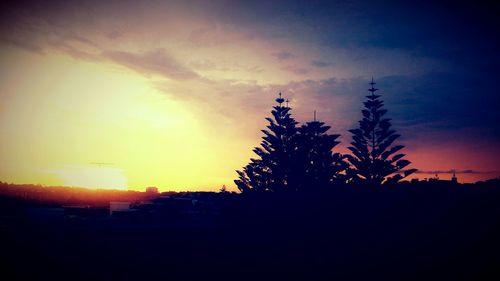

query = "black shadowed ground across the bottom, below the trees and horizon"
0;180;500;280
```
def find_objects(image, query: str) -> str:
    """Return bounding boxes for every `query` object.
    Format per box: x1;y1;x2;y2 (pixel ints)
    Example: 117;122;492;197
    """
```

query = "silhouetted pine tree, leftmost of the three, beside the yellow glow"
234;93;297;192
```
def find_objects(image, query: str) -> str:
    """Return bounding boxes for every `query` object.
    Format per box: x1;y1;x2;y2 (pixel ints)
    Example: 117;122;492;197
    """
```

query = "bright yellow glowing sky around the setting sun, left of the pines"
0;48;255;190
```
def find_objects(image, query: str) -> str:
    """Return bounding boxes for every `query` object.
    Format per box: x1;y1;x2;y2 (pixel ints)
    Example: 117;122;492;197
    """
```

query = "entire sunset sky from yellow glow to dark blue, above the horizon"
0;1;500;191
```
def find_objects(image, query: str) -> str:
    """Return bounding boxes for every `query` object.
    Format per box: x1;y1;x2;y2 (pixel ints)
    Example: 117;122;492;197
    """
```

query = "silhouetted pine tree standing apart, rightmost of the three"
347;79;416;185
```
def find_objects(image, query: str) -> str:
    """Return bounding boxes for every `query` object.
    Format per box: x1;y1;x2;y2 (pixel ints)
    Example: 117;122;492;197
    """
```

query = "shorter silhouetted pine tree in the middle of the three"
298;116;348;190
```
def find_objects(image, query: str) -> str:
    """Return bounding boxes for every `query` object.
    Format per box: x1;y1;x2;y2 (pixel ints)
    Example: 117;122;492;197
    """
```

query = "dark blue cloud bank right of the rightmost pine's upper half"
377;73;500;141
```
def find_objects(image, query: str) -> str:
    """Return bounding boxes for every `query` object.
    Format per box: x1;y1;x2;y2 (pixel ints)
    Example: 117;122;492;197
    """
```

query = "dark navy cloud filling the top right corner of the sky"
211;0;500;74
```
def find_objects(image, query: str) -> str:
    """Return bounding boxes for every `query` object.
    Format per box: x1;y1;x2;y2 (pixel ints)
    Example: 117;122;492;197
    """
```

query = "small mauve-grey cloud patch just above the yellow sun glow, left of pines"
101;48;199;80
